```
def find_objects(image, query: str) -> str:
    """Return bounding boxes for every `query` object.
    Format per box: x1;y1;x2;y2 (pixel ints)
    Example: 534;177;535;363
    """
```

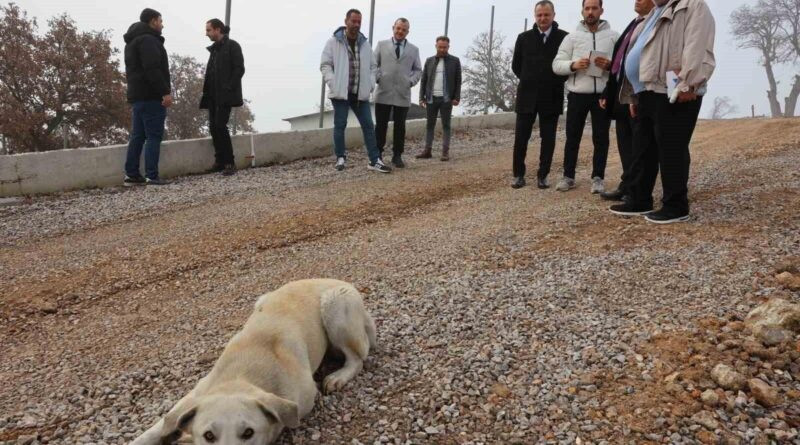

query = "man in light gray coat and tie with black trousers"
375;17;422;168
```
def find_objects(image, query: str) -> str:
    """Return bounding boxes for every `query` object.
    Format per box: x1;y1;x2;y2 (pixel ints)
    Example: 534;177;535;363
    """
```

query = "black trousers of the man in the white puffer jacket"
564;93;611;179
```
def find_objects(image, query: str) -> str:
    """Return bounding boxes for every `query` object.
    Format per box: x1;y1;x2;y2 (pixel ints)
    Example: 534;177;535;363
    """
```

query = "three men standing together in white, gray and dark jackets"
320;9;461;173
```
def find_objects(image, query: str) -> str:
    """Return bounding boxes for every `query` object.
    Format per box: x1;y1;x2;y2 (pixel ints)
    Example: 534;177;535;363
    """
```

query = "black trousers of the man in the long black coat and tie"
513;106;558;179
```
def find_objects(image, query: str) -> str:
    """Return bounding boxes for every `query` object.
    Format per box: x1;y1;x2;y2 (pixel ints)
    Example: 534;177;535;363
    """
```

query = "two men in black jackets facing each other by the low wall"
124;8;244;186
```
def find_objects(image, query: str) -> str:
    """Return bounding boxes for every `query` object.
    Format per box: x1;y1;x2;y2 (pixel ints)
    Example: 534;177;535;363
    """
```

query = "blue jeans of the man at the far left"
125;100;167;179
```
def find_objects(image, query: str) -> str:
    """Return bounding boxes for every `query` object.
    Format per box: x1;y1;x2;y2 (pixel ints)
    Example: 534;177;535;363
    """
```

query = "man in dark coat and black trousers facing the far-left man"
200;19;244;176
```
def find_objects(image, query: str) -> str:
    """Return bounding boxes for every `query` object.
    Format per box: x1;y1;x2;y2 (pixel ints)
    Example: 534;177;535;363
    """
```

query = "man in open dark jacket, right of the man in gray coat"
416;36;461;161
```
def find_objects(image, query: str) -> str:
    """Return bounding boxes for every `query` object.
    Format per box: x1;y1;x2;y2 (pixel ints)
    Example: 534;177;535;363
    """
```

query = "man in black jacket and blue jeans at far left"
124;8;172;186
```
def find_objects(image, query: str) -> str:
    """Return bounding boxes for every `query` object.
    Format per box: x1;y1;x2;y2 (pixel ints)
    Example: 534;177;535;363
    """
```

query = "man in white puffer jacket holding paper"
553;0;619;193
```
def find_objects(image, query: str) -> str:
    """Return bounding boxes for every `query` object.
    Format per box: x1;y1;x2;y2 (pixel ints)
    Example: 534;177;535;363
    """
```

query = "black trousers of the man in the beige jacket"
631;91;703;216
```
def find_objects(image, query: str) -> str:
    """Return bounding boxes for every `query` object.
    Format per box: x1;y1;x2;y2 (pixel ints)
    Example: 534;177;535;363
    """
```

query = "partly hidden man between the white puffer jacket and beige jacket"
600;0;654;201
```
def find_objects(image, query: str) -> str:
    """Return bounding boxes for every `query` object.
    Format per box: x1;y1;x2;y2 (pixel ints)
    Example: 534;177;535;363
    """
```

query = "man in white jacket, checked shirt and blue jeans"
320;9;392;173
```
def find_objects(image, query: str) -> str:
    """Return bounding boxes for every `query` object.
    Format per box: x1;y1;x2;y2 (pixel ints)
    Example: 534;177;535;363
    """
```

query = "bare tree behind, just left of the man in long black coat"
461;32;517;114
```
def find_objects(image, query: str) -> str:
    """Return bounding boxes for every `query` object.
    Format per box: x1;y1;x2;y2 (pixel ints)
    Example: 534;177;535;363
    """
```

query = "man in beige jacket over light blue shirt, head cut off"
610;0;716;224
